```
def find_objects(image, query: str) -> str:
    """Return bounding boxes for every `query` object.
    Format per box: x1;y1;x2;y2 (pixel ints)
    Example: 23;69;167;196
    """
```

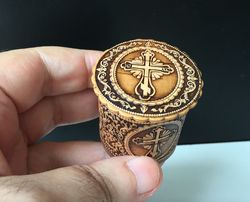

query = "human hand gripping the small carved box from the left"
0;47;162;202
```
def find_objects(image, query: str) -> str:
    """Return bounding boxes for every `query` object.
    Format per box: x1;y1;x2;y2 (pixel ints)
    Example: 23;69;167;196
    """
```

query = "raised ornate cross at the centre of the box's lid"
121;49;174;100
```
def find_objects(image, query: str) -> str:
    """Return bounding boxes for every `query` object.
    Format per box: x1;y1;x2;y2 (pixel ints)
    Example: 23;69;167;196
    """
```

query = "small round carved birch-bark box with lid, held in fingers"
92;39;203;163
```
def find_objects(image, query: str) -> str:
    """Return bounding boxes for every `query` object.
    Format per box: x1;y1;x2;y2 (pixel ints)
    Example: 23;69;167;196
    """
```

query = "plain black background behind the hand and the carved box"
0;0;250;144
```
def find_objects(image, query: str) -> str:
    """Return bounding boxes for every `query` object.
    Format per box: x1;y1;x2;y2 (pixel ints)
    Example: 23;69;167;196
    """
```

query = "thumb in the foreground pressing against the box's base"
0;156;162;202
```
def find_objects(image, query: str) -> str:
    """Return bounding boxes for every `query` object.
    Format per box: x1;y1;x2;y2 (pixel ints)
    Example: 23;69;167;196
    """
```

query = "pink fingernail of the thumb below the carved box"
127;157;162;195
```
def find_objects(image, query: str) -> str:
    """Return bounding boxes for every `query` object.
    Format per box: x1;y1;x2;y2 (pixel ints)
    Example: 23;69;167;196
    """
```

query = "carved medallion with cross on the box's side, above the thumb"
125;121;184;162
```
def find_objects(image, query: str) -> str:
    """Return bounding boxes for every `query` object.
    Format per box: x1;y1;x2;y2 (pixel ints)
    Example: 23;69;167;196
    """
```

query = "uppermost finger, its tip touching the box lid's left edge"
0;47;101;113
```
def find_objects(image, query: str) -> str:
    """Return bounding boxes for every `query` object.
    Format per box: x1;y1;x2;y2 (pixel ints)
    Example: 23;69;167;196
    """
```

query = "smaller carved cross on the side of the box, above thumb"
132;126;177;158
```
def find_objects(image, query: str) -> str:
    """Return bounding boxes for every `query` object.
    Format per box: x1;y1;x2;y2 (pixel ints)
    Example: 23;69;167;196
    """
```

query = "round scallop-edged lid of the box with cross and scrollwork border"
92;39;203;122
